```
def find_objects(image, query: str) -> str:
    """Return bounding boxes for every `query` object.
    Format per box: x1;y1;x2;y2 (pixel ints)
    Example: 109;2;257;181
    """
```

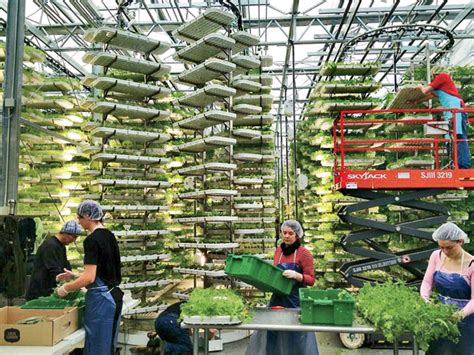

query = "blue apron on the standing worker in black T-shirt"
83;277;121;355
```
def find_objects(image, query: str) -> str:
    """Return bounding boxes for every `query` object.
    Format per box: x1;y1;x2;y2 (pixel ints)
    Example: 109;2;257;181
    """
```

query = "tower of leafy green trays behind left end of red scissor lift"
297;63;385;287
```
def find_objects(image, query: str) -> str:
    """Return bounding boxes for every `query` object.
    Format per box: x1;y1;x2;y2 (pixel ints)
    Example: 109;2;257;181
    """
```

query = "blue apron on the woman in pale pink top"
426;252;474;355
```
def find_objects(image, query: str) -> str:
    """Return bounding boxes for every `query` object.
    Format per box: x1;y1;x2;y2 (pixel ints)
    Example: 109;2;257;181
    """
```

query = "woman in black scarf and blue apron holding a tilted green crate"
246;220;318;355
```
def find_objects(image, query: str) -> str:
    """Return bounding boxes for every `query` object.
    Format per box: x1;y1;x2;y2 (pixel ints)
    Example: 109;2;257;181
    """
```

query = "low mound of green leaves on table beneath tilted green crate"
181;288;250;321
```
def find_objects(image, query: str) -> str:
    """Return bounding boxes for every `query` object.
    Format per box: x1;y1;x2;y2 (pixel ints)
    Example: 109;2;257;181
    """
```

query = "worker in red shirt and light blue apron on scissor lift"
421;67;471;169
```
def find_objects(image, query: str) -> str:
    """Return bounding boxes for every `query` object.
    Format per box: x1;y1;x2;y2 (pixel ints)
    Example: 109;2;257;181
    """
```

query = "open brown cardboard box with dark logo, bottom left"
0;307;79;346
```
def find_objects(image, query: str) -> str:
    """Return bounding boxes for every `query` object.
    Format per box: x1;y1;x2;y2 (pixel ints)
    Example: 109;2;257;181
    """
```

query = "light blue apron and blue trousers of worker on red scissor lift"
434;89;471;169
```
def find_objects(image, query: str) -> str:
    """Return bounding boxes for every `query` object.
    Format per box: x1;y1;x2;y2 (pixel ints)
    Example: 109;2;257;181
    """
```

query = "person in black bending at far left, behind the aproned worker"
26;221;82;301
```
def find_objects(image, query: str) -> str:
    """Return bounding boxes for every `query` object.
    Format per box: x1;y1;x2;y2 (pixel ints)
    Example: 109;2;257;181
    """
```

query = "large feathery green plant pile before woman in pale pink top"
356;281;460;351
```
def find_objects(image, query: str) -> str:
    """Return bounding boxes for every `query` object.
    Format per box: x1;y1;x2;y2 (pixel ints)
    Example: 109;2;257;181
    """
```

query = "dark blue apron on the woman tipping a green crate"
245;251;319;355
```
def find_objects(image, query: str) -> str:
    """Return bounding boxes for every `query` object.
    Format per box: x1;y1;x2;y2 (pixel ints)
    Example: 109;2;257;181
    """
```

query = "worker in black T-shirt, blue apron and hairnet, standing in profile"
57;200;123;355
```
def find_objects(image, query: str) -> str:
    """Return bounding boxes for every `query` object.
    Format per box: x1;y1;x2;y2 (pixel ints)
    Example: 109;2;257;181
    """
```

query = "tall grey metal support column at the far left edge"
0;0;25;214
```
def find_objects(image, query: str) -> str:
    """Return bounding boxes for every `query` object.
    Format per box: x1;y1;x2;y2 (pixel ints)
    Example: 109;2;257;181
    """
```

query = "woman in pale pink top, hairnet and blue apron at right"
420;222;474;355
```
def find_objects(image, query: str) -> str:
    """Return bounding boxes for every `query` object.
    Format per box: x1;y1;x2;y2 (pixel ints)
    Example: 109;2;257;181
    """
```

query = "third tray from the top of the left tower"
84;77;171;99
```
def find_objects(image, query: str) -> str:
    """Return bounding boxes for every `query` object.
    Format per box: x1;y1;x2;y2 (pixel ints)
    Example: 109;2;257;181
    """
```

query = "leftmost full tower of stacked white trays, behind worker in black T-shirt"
81;27;179;317
